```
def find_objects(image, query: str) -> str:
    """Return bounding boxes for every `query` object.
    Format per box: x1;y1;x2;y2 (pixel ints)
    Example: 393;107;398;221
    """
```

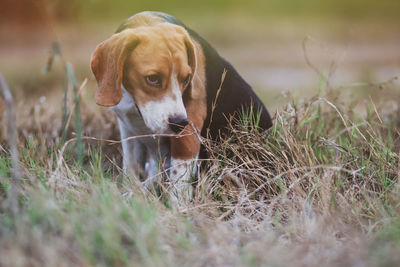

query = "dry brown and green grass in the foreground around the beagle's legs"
0;74;400;266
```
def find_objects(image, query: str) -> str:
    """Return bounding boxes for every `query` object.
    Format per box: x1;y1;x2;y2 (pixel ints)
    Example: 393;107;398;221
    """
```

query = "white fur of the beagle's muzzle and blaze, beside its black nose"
139;73;187;134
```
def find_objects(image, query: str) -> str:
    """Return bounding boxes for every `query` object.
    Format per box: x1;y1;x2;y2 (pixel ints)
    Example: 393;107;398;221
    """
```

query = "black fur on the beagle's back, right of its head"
184;26;272;139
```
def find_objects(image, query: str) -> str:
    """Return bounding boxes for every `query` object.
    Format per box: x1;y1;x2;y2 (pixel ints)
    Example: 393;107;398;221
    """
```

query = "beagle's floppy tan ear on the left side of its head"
91;29;139;107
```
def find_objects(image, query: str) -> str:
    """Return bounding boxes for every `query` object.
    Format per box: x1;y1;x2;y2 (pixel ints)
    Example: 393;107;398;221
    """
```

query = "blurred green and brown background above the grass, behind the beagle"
0;0;400;109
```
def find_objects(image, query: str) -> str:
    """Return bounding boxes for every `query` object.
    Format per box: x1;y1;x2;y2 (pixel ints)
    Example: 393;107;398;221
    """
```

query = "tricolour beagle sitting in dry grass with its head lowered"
91;12;272;203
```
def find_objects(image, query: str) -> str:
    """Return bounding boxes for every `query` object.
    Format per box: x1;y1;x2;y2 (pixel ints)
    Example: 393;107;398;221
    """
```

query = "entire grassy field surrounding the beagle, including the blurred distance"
0;0;400;266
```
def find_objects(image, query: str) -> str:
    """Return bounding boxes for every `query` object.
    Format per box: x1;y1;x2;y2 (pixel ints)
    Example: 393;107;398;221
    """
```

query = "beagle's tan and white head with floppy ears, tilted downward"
91;23;196;133
